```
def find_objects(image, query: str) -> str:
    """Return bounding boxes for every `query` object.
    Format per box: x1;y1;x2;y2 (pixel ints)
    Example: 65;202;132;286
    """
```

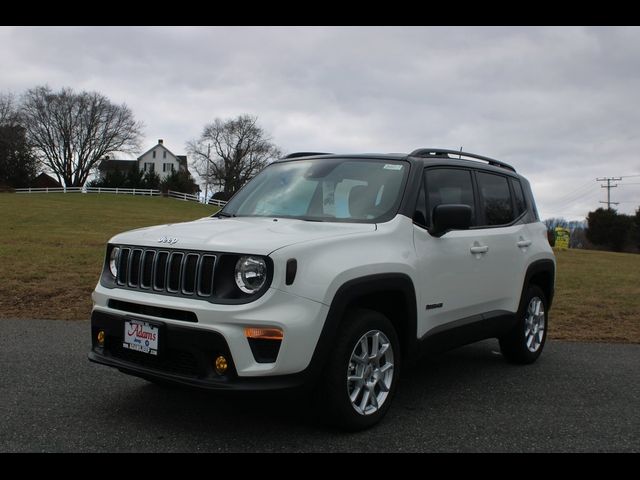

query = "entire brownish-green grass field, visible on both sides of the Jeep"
0;194;640;343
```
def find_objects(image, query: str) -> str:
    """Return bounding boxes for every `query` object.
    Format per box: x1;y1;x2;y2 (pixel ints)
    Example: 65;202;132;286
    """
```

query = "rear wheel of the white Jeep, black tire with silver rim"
499;285;549;365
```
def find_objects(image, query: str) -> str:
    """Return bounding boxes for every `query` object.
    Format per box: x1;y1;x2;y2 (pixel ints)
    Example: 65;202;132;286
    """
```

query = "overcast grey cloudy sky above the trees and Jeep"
0;27;640;219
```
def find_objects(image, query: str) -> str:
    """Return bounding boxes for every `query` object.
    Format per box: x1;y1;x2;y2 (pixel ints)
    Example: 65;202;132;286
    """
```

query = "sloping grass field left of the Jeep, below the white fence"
0;193;218;320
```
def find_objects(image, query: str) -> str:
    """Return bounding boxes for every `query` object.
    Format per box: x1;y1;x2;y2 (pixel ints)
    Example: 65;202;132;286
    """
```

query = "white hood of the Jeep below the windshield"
110;217;376;255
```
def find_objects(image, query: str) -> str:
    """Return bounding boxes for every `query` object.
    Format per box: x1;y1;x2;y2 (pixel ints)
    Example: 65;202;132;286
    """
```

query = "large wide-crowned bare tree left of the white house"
20;87;142;187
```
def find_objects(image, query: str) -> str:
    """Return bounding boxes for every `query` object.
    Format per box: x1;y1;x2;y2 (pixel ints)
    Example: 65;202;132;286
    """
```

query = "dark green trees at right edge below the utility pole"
544;207;640;253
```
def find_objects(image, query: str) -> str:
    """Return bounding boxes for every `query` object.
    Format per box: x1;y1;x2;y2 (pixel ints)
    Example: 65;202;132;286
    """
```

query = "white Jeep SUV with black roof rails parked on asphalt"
89;149;555;429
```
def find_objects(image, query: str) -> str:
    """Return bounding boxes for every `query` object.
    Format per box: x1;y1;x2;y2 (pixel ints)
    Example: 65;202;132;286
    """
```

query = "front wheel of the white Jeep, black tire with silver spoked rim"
318;309;401;431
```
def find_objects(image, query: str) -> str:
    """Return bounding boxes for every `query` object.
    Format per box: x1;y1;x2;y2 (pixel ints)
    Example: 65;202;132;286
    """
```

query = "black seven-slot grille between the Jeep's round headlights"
116;247;216;297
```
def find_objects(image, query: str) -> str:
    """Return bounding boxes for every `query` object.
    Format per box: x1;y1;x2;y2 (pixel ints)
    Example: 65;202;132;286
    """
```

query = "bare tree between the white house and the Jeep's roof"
187;115;281;200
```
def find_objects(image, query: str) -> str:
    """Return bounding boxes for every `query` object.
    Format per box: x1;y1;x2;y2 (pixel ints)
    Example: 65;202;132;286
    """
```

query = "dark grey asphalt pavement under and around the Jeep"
0;320;640;452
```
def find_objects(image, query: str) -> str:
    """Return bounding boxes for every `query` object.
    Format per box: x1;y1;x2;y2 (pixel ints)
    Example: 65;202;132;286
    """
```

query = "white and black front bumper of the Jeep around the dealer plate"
89;285;328;389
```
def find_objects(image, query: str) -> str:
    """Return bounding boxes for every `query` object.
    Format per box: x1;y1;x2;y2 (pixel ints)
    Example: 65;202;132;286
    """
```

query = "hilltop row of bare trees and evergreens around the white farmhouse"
0;86;281;200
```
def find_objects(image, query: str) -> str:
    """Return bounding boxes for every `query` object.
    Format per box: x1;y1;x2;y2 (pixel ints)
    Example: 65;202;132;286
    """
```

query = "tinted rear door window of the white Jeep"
476;172;515;226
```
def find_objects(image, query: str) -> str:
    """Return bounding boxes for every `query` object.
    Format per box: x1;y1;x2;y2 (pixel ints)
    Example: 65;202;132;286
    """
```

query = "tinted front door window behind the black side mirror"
425;168;476;226
